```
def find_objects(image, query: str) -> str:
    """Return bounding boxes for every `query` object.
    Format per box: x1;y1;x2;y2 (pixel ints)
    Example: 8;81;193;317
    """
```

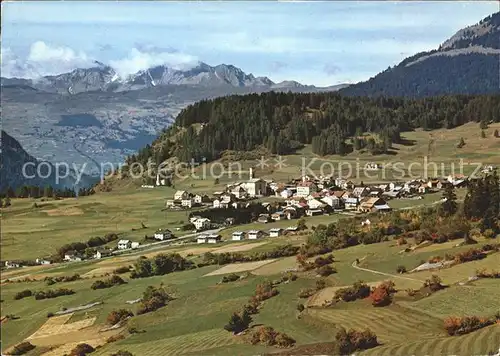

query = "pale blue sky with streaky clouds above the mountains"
1;1;499;86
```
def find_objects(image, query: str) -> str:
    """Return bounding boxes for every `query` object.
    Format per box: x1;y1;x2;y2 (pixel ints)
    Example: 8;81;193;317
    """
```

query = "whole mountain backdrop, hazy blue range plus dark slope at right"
1;13;500;189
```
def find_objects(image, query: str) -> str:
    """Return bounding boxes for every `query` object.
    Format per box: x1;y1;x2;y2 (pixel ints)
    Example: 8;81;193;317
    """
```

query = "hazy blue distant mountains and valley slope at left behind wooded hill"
2;62;345;177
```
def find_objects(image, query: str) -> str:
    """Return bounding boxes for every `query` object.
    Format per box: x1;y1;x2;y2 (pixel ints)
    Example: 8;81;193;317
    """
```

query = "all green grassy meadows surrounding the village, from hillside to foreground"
1;124;500;356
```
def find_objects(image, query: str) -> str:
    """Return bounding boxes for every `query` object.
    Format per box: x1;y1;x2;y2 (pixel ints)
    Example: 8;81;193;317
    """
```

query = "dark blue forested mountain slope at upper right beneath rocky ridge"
341;12;500;97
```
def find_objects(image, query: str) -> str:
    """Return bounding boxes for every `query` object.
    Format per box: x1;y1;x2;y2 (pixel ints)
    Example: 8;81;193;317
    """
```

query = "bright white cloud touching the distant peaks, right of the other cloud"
109;48;198;78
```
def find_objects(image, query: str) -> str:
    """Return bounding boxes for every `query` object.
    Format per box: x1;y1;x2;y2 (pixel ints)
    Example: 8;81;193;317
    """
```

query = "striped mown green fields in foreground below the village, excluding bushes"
1;232;500;355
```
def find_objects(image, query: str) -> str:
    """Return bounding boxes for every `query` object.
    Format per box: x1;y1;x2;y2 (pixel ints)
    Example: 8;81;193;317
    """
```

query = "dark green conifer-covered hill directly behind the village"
128;92;500;163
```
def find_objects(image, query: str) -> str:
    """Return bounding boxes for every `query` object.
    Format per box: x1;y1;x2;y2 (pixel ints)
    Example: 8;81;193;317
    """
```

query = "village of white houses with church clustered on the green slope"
4;164;493;268
